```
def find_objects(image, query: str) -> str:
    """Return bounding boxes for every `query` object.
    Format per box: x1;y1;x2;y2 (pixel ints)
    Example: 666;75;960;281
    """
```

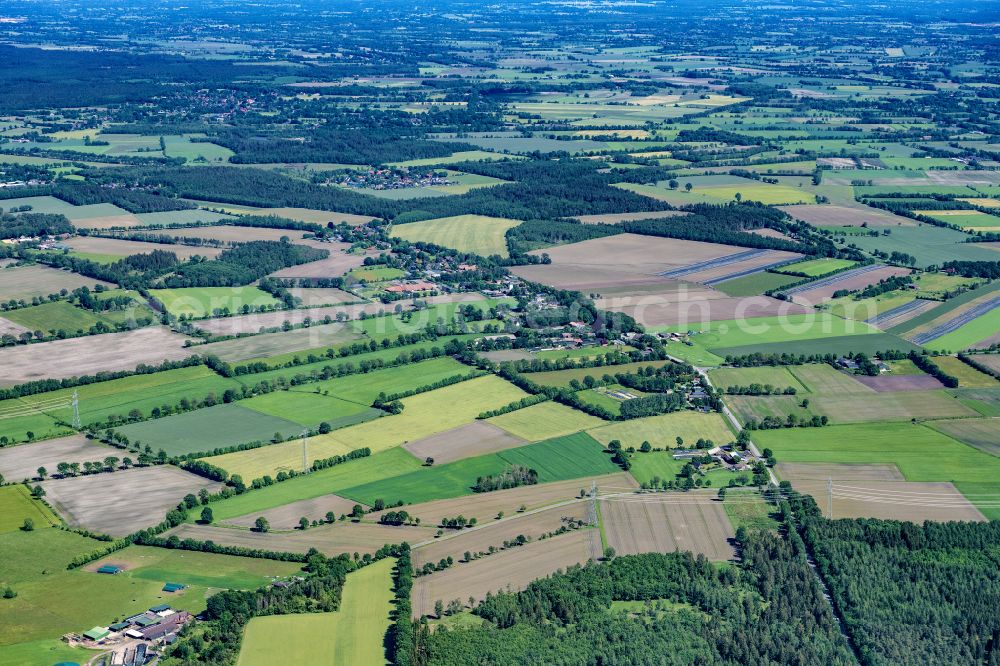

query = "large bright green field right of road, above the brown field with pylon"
754;423;1000;519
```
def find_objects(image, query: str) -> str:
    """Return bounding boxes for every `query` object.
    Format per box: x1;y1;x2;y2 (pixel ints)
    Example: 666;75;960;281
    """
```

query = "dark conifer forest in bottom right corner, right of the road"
803;517;1000;666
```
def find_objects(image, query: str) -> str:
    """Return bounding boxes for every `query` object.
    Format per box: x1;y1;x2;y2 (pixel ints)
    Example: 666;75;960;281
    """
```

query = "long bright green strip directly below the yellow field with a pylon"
203;448;421;521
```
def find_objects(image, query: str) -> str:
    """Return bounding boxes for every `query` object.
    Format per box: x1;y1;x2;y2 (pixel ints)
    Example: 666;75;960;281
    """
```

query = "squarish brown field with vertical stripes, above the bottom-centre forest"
599;491;736;561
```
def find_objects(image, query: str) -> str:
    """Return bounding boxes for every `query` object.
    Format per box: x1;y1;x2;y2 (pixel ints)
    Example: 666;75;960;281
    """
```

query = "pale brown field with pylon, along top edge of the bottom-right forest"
778;463;986;523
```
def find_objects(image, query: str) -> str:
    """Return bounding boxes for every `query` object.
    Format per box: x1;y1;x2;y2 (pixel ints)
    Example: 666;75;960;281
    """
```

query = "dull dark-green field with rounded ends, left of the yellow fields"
118;403;302;456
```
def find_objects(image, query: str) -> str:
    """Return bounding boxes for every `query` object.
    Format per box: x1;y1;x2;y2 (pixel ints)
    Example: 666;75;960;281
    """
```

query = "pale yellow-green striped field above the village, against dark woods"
391;215;521;257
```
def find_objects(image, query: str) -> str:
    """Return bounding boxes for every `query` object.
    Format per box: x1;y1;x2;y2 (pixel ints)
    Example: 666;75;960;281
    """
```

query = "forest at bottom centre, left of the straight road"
413;532;854;666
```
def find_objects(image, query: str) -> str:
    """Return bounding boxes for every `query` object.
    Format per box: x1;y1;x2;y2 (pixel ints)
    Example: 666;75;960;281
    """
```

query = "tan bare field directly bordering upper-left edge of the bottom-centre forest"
412;529;601;617
